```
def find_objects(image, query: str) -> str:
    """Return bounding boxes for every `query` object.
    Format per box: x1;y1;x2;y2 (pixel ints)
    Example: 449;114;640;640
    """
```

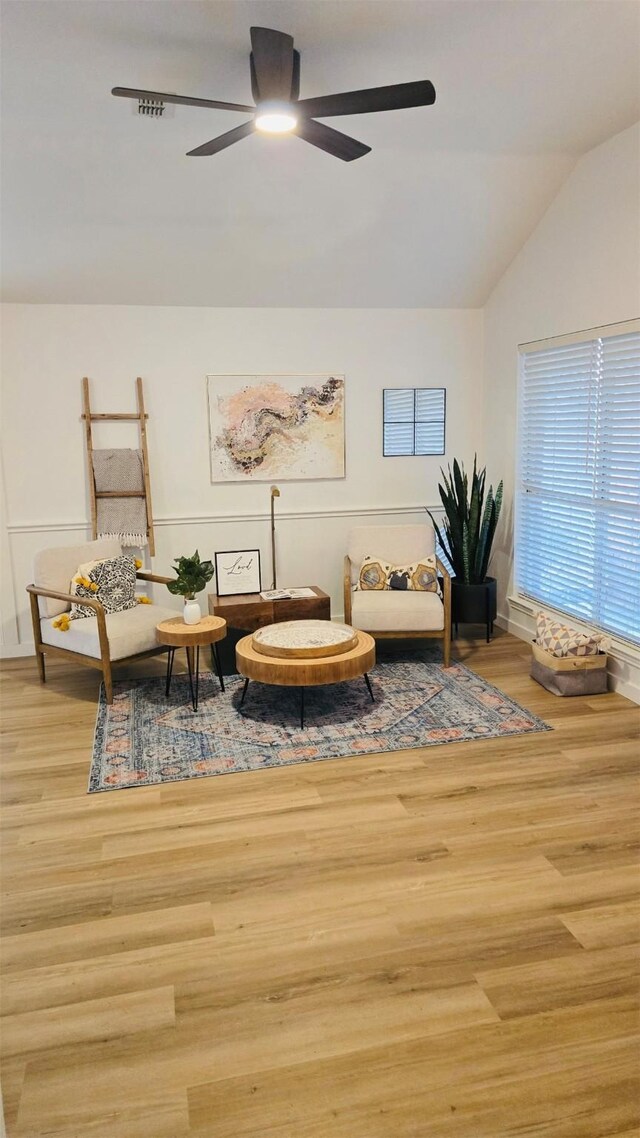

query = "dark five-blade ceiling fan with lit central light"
112;27;435;162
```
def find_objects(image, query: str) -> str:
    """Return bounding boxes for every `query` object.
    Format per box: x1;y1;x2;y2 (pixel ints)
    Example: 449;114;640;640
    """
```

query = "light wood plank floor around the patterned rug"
1;634;640;1138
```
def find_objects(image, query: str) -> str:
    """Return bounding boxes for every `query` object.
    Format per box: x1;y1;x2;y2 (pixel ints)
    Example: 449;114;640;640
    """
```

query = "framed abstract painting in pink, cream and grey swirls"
206;374;345;483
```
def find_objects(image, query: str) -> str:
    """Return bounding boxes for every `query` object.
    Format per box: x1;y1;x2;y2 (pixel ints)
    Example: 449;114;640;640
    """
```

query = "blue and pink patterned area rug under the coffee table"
89;652;551;792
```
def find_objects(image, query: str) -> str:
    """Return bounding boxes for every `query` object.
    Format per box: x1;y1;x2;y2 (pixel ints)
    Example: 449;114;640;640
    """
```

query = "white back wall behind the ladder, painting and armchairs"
2;304;482;654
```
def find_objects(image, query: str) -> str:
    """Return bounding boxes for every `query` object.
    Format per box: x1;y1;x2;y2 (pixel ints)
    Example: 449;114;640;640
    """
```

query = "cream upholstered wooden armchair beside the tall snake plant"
344;523;451;668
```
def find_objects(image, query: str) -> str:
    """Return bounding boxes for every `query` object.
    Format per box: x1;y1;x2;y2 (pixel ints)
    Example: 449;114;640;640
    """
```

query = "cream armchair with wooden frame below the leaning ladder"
27;538;175;703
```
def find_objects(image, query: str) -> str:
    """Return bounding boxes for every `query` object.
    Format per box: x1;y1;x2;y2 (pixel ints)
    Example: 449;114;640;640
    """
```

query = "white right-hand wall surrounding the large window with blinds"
484;124;640;695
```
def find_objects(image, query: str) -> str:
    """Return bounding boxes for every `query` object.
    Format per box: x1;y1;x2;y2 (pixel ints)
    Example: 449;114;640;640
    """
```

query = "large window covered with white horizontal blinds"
516;322;640;644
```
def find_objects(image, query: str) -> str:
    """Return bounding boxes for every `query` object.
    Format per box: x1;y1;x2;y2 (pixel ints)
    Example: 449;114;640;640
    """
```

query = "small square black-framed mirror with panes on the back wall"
383;387;445;456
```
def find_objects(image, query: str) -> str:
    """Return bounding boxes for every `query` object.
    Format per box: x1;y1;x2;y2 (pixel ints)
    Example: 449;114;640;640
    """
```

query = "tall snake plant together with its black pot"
428;457;502;641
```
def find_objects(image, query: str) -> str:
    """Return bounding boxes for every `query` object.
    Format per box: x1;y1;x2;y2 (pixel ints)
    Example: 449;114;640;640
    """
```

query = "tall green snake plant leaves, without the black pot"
427;457;502;585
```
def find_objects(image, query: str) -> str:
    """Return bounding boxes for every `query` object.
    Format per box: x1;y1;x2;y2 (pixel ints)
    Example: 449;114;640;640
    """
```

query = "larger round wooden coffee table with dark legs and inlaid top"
236;620;376;727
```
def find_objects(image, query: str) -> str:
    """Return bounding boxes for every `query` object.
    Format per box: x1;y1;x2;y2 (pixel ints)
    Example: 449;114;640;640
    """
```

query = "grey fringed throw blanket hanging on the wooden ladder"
93;450;148;547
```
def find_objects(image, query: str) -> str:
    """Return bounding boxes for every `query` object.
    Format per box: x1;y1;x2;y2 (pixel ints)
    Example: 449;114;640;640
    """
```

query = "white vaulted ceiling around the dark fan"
2;0;640;307
